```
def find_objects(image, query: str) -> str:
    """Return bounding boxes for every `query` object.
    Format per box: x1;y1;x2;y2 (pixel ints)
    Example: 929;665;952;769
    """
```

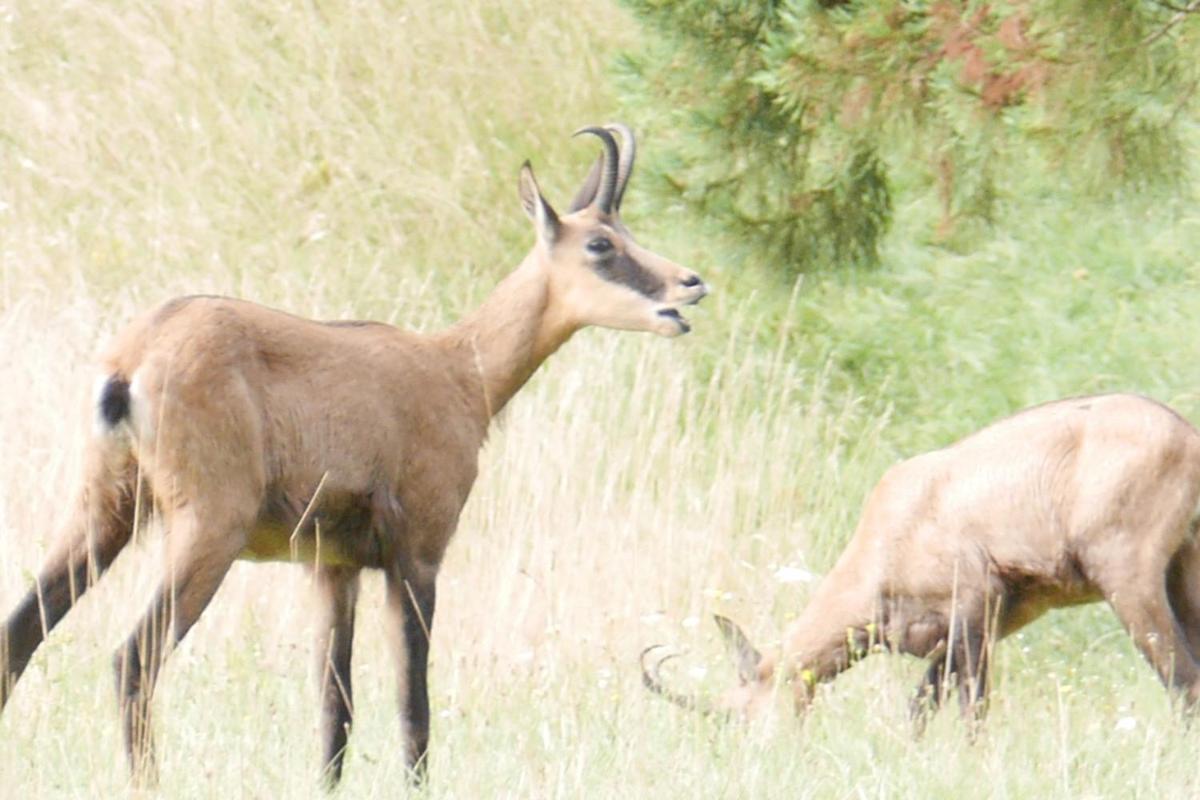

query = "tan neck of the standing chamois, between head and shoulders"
442;252;578;419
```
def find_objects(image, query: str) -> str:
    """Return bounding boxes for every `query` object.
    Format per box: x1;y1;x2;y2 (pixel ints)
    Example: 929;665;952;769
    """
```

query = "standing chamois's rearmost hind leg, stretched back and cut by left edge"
0;441;137;709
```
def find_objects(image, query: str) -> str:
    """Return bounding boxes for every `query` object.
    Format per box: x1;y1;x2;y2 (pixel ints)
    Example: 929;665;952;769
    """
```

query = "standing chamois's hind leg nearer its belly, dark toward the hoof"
113;498;253;783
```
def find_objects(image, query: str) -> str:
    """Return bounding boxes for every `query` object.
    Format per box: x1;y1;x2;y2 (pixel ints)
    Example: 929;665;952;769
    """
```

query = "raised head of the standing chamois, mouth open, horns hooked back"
520;124;708;336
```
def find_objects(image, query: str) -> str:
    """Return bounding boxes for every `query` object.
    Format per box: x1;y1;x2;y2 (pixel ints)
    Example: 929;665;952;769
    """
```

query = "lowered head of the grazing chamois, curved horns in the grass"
642;614;775;721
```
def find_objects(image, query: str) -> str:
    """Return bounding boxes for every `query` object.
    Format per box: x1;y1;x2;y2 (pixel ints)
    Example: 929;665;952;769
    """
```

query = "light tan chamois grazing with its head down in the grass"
642;395;1200;729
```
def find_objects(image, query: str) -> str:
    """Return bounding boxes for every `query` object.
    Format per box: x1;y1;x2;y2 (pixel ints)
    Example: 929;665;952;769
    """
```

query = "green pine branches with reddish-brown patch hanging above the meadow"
624;0;1200;271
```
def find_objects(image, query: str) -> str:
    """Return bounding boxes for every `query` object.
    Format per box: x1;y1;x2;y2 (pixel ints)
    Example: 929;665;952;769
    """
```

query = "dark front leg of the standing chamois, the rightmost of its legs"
386;564;437;781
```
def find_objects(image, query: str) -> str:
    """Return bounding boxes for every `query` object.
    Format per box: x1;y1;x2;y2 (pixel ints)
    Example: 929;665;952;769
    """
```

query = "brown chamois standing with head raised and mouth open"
0;125;708;783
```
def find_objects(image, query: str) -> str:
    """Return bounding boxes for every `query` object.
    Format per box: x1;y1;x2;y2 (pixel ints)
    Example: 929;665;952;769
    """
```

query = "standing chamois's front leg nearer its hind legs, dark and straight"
314;567;359;788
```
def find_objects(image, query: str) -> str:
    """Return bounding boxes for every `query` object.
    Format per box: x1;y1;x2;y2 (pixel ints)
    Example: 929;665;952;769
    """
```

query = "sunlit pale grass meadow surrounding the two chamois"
0;0;1200;798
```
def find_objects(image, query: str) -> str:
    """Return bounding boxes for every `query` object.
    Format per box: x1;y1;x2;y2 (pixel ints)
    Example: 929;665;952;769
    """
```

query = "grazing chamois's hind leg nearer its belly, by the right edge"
1100;570;1200;706
